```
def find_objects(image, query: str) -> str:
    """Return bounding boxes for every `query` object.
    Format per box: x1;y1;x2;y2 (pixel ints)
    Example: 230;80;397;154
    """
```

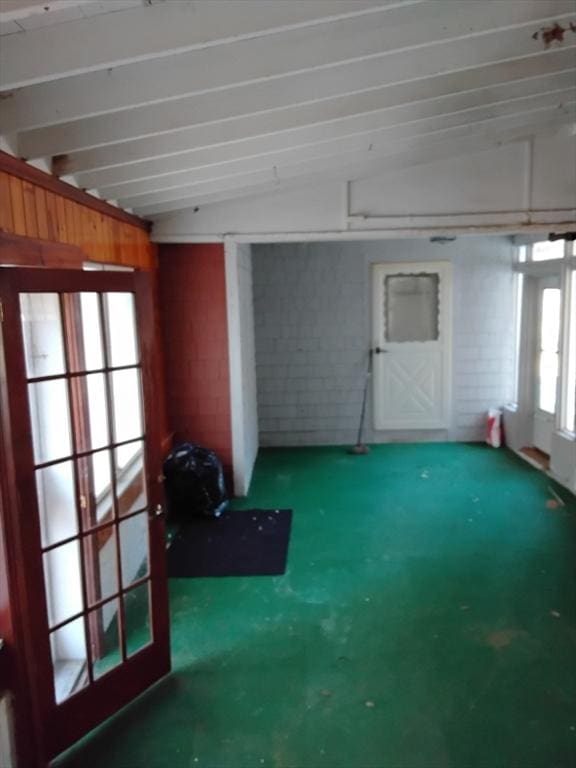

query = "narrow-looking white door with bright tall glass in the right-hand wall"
533;276;562;455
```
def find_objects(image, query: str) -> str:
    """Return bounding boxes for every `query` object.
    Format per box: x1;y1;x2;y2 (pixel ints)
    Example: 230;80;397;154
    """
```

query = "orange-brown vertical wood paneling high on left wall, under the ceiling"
0;153;156;269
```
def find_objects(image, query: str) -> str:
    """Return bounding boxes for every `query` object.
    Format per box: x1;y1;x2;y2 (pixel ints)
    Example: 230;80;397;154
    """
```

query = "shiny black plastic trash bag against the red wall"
164;443;230;520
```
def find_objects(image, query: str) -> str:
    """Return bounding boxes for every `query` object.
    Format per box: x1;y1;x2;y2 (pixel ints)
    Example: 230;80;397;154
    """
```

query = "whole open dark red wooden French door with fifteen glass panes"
0;268;170;760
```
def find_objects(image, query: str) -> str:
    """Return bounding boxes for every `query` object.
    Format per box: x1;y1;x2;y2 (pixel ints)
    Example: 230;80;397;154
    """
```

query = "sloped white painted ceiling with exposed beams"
0;0;576;217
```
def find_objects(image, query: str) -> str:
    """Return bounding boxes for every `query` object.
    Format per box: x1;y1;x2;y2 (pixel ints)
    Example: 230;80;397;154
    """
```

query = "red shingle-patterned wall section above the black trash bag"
159;243;232;478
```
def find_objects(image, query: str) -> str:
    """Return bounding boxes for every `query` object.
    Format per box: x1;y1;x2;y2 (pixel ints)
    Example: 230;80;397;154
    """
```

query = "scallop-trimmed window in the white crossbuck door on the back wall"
384;274;440;343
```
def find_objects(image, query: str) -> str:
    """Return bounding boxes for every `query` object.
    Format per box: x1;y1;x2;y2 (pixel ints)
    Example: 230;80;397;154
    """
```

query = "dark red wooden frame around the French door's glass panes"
0;268;170;766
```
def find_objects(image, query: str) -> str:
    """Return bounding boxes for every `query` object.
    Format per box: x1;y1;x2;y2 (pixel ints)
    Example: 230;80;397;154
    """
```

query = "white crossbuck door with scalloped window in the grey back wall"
373;262;451;430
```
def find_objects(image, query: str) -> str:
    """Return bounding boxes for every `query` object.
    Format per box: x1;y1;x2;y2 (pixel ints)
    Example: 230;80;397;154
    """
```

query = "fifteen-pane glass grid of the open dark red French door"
20;286;151;703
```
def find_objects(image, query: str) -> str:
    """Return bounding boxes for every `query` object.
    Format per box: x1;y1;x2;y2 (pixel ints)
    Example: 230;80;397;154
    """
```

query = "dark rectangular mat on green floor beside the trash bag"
168;509;292;578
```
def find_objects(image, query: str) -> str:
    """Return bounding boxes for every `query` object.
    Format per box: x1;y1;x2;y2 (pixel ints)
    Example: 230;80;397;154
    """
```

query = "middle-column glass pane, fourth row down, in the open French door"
83;525;118;605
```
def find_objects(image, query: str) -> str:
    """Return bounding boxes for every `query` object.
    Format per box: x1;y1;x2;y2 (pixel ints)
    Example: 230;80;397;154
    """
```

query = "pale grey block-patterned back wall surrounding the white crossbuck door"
252;237;515;446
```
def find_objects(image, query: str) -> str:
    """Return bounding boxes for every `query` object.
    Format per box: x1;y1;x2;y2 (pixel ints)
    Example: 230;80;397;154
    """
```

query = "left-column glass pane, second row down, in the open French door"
28;379;72;464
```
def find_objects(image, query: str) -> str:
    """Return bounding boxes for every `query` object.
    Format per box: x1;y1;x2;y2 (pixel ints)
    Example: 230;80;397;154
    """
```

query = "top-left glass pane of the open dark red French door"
20;293;66;379
